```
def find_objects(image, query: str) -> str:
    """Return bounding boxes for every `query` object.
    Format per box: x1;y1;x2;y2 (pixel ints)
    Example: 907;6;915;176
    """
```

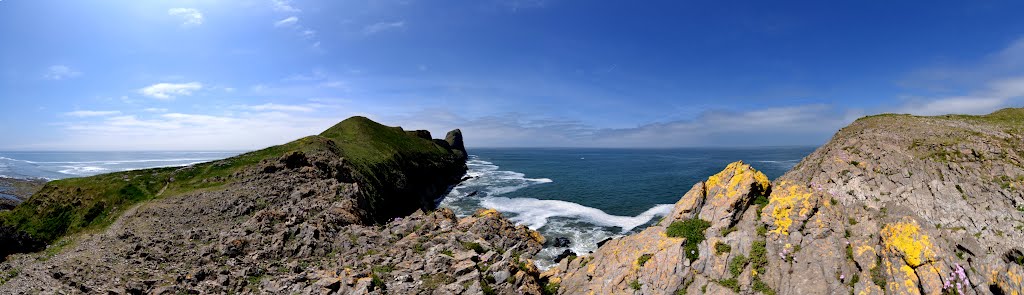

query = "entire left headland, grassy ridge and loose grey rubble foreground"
0;117;544;294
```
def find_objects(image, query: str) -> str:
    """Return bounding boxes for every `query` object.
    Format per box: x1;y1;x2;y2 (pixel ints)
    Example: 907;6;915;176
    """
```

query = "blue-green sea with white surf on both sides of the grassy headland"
0;146;814;268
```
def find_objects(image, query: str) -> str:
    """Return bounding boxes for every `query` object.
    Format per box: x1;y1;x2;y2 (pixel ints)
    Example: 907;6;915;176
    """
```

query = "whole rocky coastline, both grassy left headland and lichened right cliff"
0;109;1024;294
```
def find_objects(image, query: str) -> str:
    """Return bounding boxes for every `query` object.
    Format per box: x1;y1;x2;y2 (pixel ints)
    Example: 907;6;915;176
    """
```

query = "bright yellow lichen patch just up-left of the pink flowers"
881;218;935;267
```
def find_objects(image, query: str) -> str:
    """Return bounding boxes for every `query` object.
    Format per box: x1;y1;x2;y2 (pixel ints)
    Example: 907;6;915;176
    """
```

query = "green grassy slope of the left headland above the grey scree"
0;117;466;243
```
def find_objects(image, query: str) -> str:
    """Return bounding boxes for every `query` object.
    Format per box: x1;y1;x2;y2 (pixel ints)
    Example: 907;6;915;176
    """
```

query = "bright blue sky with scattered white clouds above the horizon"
0;0;1024;151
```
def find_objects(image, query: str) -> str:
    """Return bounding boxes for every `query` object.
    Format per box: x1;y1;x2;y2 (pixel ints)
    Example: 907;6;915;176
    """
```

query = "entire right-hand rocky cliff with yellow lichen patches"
542;109;1024;294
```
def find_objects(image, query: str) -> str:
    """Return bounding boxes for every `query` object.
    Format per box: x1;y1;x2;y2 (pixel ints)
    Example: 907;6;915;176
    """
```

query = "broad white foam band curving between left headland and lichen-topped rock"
480;197;672;233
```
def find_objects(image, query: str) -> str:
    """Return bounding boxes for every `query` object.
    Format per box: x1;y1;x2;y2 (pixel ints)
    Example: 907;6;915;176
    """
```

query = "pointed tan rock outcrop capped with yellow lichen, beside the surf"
542;162;770;294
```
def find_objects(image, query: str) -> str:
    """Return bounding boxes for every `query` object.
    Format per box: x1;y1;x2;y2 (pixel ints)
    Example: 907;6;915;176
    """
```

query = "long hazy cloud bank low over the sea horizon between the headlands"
368;104;863;148
